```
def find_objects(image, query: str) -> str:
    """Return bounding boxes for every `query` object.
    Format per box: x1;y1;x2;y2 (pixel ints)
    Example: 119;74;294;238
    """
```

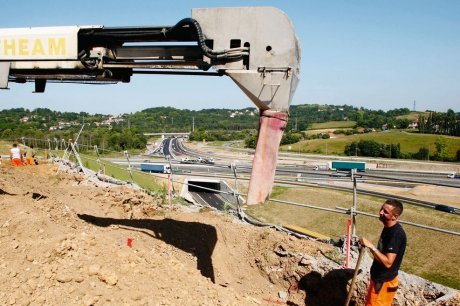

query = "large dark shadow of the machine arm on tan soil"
78;214;217;283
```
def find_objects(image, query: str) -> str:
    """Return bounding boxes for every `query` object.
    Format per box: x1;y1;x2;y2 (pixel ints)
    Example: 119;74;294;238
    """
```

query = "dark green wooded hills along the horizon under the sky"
0;104;460;150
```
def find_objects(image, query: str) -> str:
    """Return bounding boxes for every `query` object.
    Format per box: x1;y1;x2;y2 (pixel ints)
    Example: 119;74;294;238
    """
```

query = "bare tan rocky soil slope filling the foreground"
0;161;460;306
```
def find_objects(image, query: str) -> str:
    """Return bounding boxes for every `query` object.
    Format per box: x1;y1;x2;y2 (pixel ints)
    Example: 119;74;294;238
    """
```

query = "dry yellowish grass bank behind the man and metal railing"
248;187;460;289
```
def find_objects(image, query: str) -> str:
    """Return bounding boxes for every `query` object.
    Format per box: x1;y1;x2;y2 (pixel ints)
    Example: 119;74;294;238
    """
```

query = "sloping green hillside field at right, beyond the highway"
280;130;460;157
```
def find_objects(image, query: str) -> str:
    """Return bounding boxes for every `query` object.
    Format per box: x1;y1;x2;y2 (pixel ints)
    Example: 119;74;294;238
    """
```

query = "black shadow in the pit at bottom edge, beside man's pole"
299;269;354;306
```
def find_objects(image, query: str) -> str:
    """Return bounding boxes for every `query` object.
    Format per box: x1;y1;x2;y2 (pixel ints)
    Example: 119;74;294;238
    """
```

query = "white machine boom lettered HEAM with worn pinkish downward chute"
0;7;300;204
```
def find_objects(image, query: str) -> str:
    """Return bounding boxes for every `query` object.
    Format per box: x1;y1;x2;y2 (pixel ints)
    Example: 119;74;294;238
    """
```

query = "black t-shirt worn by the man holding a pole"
371;223;407;282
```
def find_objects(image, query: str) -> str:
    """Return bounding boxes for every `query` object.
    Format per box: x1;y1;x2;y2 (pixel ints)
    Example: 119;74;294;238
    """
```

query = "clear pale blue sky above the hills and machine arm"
0;0;460;114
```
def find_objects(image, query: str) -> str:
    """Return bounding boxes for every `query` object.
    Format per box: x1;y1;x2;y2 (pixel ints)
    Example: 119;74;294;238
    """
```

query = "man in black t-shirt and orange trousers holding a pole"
359;199;407;306
